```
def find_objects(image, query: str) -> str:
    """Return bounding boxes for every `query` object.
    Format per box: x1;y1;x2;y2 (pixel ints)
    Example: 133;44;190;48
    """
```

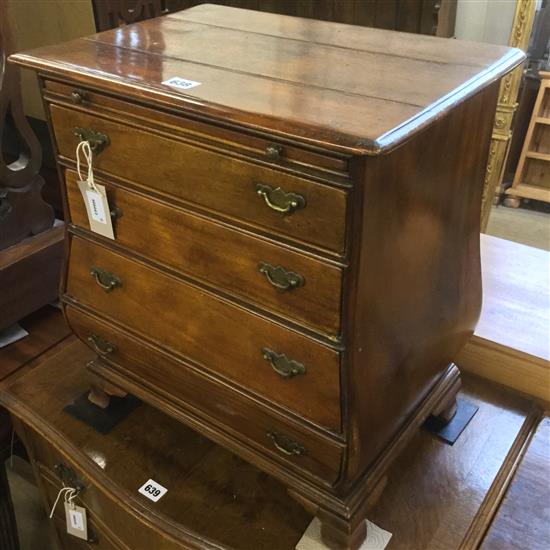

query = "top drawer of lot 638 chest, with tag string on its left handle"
50;105;346;254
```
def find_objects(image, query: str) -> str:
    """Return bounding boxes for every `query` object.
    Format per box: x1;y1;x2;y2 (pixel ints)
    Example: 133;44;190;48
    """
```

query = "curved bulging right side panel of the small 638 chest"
345;81;498;479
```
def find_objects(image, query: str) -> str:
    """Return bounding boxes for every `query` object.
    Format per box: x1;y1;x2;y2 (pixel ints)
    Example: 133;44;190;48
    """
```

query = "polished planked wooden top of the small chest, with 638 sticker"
11;4;524;155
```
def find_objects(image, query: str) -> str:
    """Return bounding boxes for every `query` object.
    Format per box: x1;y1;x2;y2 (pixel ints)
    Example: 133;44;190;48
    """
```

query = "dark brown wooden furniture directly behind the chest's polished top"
92;0;457;37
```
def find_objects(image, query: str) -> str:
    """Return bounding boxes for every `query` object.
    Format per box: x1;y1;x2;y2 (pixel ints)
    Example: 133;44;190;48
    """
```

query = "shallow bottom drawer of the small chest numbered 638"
65;306;343;485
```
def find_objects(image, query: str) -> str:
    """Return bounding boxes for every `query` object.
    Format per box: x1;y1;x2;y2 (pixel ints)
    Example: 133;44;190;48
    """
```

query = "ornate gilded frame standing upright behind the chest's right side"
481;0;537;233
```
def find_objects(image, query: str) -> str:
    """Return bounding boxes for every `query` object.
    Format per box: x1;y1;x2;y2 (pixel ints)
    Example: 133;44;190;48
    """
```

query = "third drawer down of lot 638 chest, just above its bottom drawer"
66;237;341;432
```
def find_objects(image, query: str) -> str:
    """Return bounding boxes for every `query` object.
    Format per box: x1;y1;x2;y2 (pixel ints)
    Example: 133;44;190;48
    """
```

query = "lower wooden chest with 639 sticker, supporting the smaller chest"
0;339;548;550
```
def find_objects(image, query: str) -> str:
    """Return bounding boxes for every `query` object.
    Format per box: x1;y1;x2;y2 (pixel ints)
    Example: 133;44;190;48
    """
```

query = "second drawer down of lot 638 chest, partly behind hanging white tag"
65;170;342;336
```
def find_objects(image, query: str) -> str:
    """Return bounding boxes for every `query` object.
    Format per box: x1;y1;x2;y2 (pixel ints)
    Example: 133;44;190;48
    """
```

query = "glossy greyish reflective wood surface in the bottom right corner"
481;417;550;550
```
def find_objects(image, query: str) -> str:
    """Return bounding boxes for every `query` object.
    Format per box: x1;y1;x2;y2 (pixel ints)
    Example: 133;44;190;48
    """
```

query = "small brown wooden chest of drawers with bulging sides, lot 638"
12;5;523;548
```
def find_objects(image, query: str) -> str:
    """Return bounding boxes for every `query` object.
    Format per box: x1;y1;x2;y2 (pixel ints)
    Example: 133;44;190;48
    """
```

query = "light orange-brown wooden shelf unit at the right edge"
504;72;550;207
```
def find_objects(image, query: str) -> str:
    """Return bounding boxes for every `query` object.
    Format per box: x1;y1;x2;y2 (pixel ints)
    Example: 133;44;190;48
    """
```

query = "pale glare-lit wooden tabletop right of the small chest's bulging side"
456;235;550;402
